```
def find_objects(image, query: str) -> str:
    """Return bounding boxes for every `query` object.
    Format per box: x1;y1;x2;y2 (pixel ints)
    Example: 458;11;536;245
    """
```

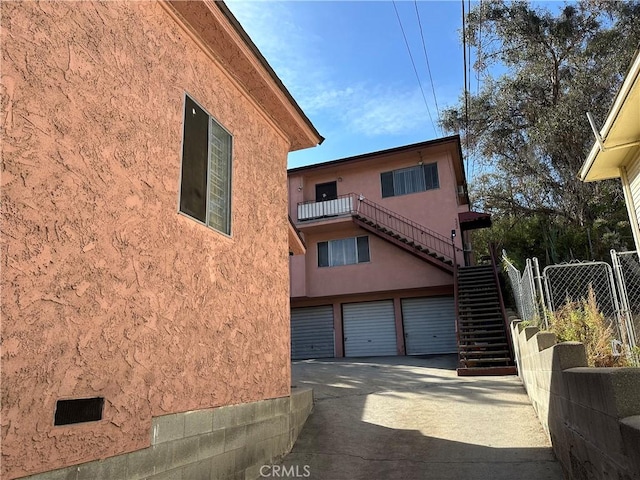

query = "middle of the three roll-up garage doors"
342;300;398;357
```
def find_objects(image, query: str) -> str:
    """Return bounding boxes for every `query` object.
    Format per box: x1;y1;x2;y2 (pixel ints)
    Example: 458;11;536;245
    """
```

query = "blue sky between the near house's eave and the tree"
227;0;557;172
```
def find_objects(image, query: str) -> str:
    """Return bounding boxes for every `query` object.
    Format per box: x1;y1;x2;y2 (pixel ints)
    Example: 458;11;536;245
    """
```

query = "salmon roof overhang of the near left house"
161;0;324;151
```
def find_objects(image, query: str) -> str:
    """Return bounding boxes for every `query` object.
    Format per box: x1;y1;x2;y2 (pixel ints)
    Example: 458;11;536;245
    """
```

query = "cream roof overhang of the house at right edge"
578;51;640;182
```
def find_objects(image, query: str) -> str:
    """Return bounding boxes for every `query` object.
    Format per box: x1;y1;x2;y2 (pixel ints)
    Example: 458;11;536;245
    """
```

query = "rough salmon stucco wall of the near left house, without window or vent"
0;2;290;478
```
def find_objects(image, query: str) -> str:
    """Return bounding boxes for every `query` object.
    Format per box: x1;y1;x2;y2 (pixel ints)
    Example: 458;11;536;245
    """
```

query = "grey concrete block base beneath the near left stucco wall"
19;389;313;480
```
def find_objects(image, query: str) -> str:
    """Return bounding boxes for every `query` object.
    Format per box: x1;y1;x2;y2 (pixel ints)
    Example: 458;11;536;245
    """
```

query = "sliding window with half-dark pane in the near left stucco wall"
180;96;231;235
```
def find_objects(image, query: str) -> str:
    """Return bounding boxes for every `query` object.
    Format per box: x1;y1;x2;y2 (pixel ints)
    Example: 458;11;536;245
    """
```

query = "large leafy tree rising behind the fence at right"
442;0;640;262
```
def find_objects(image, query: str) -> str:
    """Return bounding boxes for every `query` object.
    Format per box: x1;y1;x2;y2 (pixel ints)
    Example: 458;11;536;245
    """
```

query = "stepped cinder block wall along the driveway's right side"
511;319;640;480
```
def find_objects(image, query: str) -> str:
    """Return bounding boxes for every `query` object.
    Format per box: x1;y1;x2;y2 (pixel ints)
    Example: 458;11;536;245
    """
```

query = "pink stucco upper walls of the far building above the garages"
289;146;468;298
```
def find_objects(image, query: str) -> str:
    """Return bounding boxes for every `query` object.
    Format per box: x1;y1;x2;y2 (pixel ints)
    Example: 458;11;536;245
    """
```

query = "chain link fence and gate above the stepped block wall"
502;250;640;358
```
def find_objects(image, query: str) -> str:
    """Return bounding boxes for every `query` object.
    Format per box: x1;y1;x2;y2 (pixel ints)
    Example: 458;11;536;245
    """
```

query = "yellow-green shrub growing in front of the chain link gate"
549;290;628;367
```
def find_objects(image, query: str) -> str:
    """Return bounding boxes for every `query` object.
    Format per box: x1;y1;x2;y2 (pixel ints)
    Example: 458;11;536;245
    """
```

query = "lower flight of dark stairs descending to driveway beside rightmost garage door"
456;265;517;375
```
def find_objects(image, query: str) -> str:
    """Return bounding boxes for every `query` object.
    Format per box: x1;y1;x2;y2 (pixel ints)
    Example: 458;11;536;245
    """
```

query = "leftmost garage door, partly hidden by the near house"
291;305;335;360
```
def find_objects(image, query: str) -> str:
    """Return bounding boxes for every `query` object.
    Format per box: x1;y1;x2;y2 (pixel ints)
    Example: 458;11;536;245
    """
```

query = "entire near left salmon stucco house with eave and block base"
0;1;322;480
